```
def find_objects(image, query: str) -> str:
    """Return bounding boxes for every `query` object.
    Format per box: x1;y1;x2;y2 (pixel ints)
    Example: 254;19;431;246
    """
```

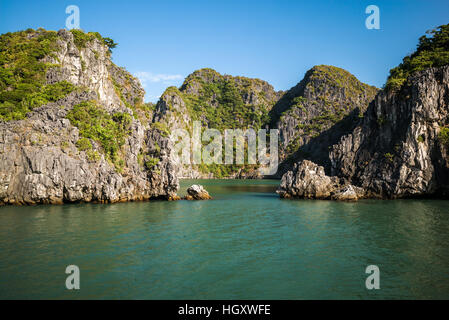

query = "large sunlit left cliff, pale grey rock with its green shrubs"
0;30;178;204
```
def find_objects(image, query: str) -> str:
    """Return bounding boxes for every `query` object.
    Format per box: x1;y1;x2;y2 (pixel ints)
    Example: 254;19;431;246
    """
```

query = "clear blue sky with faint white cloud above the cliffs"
0;0;449;101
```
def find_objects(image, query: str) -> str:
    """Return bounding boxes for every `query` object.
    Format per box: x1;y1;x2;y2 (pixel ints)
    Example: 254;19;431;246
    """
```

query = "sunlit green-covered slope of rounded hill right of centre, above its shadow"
271;65;378;161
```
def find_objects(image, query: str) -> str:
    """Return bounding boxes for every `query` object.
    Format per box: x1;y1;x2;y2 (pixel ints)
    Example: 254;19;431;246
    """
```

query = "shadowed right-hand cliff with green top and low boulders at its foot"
278;25;449;199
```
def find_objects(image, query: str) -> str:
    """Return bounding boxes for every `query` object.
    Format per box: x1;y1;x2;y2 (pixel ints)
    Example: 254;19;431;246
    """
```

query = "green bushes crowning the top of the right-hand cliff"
386;24;449;90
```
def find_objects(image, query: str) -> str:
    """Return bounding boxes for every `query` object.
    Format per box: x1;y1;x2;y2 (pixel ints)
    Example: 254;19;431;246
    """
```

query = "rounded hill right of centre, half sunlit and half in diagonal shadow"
270;65;377;176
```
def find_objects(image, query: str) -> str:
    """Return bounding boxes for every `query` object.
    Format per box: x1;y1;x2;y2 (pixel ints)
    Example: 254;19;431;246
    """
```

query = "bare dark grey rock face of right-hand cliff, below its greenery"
330;66;449;198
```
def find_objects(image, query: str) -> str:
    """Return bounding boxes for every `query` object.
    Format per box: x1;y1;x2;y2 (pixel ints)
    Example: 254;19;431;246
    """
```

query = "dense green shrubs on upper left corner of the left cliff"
0;29;68;121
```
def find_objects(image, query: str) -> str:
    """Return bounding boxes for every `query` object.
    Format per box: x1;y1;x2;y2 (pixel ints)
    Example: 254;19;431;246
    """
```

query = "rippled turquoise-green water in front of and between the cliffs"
0;180;449;299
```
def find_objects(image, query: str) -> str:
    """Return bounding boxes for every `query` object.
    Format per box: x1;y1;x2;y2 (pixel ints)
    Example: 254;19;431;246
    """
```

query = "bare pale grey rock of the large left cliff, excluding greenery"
0;30;179;205
